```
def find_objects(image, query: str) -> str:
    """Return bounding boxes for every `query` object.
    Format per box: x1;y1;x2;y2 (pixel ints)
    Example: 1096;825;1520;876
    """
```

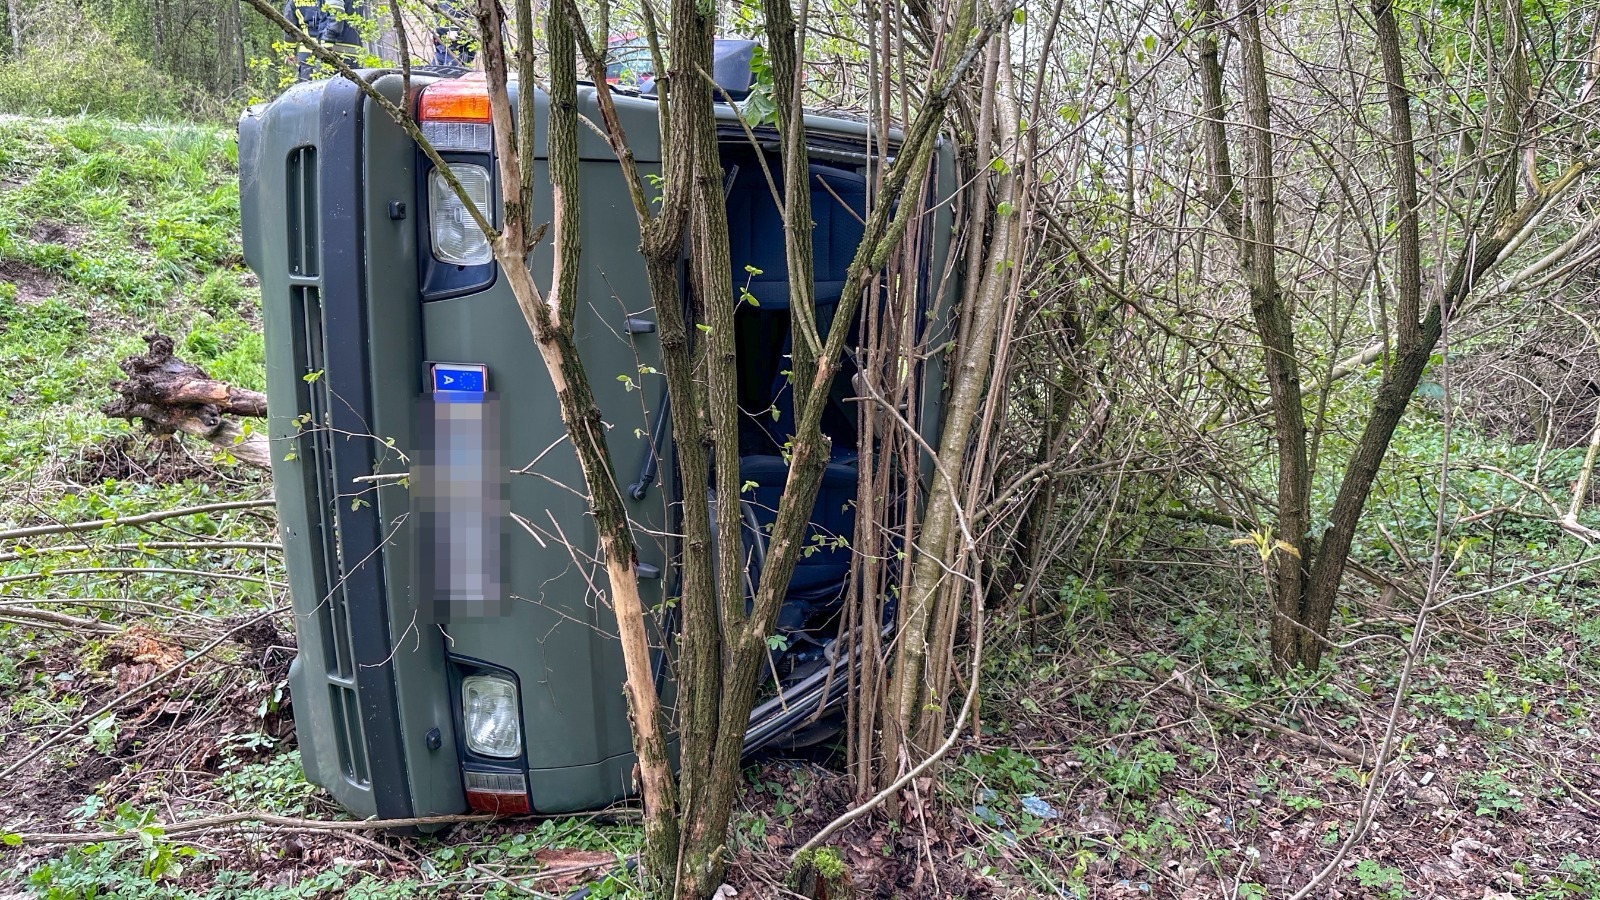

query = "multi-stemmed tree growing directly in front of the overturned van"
492;0;997;883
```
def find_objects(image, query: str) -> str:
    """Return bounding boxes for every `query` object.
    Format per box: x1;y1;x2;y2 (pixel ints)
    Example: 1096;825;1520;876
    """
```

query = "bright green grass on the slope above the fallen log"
0;119;262;490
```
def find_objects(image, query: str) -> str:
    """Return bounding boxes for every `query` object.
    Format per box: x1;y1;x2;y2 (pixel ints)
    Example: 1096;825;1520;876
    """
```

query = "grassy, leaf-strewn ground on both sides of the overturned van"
0;119;1600;900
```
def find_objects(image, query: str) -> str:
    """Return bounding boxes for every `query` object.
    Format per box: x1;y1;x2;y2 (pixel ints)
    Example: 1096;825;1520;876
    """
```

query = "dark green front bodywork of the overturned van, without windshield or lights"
240;63;955;818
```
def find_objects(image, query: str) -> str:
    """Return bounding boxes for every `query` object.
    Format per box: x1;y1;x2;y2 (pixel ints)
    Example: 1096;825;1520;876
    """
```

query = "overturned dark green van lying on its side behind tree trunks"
240;45;955;818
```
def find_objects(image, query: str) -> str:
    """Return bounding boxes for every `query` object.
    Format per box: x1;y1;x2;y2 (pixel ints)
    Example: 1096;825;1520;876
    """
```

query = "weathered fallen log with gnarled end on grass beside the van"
101;335;272;469
